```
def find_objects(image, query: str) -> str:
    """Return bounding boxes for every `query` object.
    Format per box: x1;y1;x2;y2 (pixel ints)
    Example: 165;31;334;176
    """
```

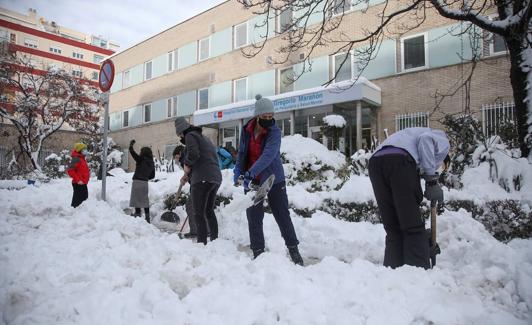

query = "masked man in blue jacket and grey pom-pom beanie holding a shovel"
233;95;303;265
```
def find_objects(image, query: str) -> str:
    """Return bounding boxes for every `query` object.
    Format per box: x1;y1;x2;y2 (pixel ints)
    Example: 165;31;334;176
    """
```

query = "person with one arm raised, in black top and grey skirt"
129;140;155;223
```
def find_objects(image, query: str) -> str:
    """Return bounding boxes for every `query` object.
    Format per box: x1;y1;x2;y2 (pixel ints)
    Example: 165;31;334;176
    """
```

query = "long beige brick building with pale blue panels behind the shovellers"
104;0;513;167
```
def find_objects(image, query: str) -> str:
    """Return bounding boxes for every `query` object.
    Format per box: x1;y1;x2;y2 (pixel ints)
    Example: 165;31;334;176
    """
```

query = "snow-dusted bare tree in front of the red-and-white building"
0;53;99;171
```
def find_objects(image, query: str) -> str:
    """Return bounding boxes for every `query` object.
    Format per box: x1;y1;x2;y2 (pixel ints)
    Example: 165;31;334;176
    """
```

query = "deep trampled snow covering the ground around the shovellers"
0;138;532;325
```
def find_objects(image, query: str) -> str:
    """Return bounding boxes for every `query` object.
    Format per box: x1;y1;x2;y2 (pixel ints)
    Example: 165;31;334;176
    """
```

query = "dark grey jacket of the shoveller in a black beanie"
183;126;222;185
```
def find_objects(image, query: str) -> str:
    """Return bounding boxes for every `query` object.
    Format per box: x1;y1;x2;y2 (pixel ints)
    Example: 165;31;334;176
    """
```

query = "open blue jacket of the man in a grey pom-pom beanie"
235;119;285;184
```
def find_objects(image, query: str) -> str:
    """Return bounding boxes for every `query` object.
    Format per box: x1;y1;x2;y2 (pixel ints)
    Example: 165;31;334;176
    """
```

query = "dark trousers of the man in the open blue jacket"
246;182;299;251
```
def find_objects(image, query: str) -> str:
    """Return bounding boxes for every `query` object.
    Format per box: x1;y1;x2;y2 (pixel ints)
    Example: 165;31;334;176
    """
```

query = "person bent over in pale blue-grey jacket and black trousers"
368;128;449;269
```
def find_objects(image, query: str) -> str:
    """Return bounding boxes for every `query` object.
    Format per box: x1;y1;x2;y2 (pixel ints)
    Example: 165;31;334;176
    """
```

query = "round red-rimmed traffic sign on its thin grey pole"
98;60;115;201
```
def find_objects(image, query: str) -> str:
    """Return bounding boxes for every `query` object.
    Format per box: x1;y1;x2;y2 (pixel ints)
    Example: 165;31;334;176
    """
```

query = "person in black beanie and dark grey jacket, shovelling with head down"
174;117;222;245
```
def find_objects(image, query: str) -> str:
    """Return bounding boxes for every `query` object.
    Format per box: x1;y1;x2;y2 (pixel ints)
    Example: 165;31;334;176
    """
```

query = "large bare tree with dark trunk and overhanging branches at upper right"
237;0;532;157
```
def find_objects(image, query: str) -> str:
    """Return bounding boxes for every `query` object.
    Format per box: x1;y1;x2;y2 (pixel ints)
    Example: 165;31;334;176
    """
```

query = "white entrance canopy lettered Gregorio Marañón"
193;77;381;126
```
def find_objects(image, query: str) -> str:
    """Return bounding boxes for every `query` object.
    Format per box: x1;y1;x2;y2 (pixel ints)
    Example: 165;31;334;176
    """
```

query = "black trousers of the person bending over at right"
368;154;430;269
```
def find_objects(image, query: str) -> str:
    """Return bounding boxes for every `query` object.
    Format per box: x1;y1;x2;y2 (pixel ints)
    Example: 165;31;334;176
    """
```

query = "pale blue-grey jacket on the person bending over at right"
375;128;450;175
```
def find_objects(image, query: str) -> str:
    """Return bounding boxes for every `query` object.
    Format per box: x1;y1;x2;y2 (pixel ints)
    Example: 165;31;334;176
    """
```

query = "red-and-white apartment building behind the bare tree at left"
0;7;119;167
